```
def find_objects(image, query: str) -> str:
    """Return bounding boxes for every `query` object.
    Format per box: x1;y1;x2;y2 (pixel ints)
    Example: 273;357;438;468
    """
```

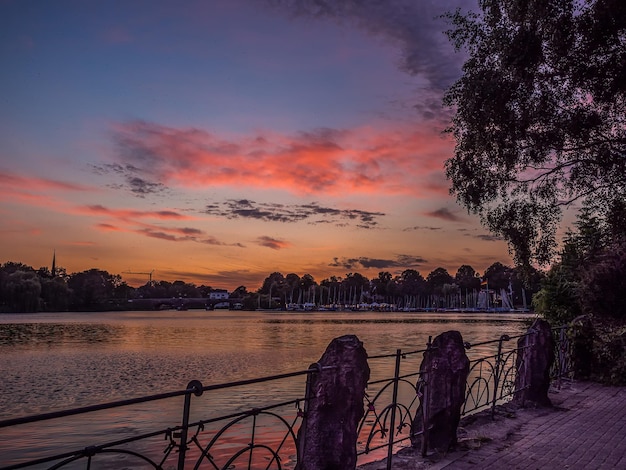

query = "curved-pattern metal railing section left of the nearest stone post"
0;365;326;470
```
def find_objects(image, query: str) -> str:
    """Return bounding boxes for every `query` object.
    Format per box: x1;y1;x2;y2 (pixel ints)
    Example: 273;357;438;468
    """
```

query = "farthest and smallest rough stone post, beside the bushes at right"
513;318;554;406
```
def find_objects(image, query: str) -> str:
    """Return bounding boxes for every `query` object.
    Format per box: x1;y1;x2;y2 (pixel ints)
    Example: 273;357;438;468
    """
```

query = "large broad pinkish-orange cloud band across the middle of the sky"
115;121;453;197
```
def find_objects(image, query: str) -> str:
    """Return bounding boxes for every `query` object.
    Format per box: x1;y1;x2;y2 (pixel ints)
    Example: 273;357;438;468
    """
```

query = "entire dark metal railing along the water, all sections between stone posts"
0;328;571;470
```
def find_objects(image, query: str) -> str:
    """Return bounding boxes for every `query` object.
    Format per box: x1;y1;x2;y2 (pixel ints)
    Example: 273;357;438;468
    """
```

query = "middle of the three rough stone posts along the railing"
411;331;469;454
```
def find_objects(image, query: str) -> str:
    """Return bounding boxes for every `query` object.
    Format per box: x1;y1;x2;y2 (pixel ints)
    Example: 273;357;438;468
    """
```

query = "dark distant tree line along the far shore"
0;261;542;312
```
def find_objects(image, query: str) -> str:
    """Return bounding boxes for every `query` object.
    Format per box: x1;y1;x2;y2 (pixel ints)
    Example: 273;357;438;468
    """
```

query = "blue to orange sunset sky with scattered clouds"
0;0;512;290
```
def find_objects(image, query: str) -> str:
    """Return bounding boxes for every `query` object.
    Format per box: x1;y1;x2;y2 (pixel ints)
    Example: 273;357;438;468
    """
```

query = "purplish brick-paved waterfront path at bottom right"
361;382;626;470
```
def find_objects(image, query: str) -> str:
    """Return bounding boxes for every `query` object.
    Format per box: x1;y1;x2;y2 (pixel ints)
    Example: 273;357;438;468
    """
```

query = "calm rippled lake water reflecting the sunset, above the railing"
0;311;530;464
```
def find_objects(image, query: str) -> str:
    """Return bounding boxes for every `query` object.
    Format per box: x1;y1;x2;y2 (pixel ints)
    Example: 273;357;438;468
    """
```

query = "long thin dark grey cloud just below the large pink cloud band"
206;199;385;228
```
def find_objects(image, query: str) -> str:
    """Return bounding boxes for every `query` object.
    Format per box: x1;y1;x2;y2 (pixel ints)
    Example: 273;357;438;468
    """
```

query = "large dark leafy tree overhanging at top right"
444;0;626;266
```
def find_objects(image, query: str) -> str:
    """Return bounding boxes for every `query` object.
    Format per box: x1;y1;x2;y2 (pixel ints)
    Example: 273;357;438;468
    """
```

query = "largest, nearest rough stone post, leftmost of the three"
296;335;370;470
